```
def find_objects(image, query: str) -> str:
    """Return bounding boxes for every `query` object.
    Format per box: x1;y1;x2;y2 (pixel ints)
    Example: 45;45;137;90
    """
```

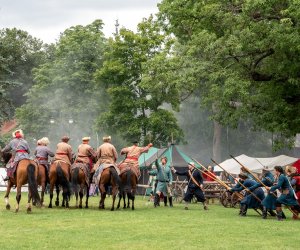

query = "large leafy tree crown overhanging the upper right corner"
159;0;300;149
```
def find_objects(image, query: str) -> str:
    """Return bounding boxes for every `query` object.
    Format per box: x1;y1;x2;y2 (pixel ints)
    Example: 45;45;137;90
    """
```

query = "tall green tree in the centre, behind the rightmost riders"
97;17;183;145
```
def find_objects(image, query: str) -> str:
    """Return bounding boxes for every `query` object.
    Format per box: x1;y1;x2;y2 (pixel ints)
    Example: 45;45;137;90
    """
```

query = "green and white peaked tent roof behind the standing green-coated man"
139;144;200;168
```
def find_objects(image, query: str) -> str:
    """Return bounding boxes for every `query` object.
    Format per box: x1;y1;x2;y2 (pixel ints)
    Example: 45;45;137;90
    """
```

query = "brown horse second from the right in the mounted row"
99;166;122;211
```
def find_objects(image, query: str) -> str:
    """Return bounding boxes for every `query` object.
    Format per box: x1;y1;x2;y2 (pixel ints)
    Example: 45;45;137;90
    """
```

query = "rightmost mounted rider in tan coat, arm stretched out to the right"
119;140;152;179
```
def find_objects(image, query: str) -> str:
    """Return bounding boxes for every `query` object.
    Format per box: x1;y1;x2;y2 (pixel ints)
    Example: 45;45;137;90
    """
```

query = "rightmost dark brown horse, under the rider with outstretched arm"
117;169;137;210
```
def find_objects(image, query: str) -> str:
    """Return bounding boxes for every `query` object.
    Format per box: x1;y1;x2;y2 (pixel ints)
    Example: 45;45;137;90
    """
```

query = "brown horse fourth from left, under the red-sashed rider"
71;162;90;208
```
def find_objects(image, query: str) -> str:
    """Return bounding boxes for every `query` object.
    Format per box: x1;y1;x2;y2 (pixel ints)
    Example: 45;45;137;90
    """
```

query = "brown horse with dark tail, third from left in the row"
48;160;71;208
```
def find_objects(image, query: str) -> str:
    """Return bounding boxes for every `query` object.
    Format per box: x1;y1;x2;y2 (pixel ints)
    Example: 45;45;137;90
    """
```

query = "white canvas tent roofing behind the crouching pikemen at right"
214;154;298;174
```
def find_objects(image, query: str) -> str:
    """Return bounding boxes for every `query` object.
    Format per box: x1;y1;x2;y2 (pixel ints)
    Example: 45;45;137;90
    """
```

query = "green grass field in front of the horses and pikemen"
0;192;300;249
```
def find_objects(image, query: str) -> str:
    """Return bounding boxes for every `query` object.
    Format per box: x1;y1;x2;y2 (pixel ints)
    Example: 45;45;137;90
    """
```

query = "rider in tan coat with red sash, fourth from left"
75;137;96;170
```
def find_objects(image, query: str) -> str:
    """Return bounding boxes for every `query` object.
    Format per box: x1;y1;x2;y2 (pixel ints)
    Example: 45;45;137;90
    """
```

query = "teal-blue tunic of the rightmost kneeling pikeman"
270;174;298;206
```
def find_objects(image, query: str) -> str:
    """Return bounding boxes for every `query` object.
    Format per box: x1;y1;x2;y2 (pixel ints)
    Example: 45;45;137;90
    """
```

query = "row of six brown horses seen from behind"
0;150;137;213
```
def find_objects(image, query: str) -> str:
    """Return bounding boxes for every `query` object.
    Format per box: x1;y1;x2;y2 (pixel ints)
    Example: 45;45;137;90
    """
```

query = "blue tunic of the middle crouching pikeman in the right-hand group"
249;172;277;210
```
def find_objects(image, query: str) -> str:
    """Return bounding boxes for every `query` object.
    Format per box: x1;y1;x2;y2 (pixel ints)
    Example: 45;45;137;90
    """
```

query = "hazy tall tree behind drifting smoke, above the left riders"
17;20;106;147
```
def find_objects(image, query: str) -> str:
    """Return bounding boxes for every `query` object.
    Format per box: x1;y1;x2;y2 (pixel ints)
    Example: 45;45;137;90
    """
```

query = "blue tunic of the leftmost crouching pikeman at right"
231;178;265;208
